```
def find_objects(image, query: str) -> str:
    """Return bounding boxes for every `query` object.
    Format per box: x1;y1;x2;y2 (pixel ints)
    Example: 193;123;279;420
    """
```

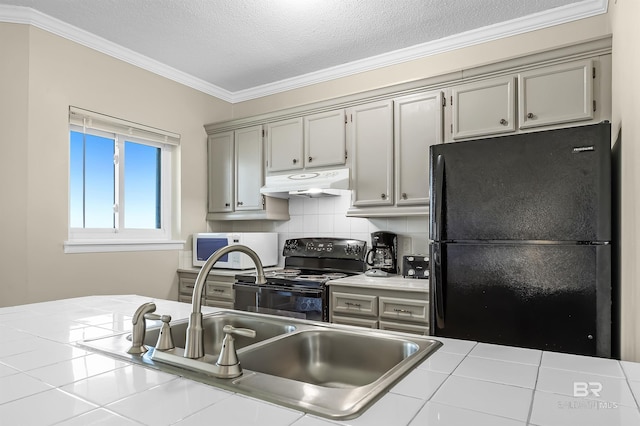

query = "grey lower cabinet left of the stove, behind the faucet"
178;272;235;309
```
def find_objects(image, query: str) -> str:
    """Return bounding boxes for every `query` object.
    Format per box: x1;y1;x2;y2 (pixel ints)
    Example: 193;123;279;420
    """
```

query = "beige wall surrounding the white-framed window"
0;24;231;306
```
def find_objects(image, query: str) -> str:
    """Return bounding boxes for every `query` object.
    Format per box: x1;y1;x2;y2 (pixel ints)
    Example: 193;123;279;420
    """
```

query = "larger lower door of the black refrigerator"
430;244;611;357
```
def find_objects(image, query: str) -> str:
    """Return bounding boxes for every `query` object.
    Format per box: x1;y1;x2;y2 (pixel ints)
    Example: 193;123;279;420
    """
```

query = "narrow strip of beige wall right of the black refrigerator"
609;0;640;361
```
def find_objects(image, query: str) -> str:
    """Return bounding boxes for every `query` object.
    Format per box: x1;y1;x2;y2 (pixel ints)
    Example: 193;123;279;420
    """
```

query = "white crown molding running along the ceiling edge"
0;0;608;103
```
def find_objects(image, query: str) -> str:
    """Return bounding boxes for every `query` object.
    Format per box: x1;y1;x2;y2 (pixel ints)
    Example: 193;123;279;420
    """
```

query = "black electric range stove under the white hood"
233;237;367;322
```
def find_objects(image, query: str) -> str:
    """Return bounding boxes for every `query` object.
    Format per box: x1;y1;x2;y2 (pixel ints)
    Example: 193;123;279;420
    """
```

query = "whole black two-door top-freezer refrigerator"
429;122;612;357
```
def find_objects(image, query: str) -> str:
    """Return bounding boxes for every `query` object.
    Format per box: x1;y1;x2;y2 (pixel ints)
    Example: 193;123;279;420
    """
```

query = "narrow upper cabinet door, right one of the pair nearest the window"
235;125;264;211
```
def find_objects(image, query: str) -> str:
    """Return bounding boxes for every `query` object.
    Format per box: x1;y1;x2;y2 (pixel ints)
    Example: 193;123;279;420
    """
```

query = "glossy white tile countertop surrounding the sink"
0;295;640;426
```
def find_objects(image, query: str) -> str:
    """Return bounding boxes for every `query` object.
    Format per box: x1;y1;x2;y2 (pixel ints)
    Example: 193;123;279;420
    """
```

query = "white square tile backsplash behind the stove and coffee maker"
202;192;429;265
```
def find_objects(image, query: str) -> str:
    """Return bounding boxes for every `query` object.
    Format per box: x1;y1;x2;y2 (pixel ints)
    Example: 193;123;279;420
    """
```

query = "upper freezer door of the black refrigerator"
430;123;611;241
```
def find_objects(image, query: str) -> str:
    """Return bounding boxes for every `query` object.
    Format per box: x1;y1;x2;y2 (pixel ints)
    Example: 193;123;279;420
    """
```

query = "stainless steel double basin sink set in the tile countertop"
81;311;442;419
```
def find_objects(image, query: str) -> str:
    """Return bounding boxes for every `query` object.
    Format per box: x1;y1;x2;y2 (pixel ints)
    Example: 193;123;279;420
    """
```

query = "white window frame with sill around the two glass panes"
64;107;185;253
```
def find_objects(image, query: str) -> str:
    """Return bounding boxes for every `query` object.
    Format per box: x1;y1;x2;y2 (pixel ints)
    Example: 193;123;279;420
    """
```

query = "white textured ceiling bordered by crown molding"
0;0;607;98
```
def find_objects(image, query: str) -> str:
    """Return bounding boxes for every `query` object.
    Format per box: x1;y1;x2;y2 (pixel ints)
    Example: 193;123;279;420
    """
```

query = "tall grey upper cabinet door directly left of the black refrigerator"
393;91;443;206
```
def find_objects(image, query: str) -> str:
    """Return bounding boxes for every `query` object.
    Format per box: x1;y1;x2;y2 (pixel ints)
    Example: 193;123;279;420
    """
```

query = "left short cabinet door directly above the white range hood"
267;118;304;172
